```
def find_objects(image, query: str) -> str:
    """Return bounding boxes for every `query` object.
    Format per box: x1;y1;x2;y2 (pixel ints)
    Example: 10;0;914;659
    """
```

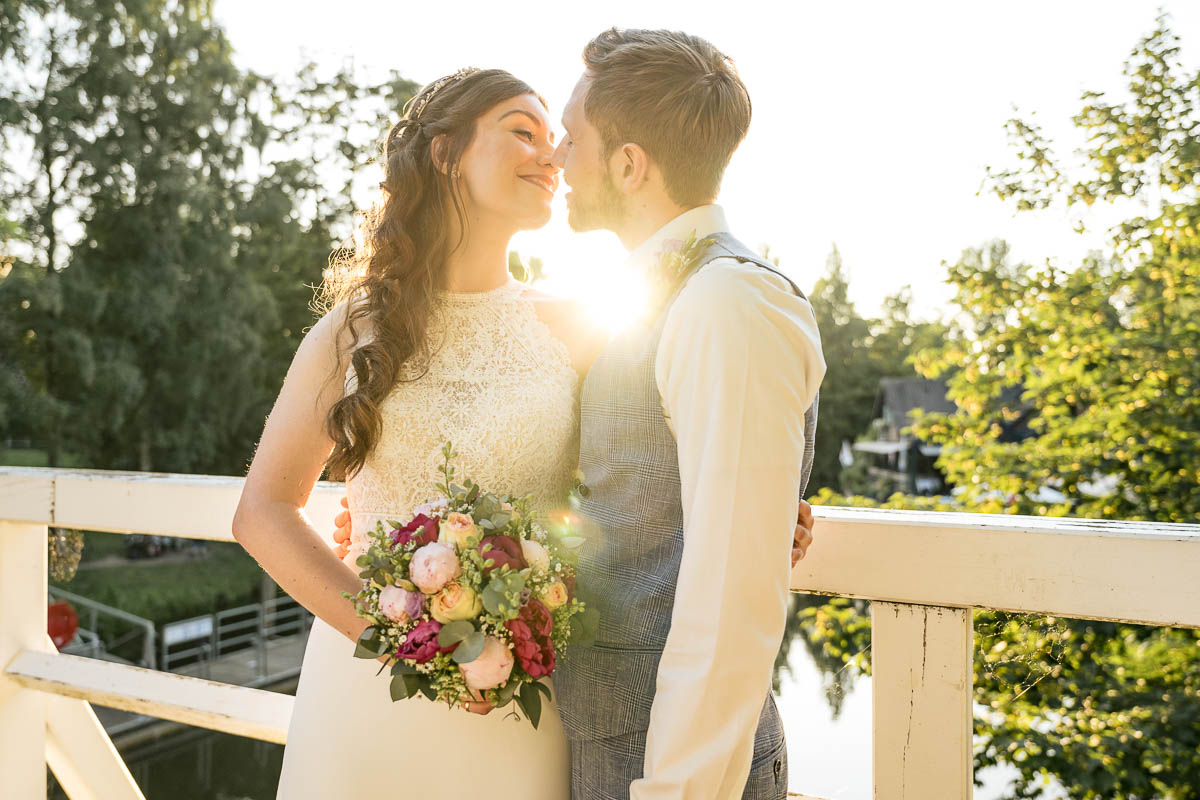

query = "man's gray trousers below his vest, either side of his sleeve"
571;697;787;800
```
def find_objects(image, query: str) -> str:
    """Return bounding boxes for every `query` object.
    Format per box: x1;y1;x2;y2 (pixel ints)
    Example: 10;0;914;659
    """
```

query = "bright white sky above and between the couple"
215;0;1200;326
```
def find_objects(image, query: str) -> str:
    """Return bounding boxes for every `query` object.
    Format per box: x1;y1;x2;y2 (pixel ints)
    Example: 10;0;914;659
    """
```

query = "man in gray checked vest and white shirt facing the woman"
554;29;826;800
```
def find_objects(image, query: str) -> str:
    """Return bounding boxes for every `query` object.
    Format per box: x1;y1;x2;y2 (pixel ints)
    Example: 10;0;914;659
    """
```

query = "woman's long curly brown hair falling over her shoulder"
322;70;546;480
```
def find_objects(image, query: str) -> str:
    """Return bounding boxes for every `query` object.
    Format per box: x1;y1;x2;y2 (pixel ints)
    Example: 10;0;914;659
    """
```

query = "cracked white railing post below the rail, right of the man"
871;601;973;800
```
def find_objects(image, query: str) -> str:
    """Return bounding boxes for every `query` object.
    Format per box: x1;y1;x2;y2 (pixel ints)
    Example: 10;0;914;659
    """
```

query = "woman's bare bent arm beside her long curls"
233;306;367;640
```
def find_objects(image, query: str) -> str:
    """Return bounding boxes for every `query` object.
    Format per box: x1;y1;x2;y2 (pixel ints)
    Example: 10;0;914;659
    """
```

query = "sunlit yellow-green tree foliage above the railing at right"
917;19;1200;522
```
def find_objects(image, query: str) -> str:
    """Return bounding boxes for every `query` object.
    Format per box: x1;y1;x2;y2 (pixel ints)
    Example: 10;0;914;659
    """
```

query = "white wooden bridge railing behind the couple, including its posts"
0;468;1200;800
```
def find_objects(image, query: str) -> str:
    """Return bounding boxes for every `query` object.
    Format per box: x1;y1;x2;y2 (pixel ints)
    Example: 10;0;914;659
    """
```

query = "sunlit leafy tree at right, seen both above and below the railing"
805;18;1200;800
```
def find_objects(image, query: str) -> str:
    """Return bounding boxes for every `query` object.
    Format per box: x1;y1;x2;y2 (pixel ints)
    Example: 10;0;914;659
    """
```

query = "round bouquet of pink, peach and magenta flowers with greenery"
343;443;584;728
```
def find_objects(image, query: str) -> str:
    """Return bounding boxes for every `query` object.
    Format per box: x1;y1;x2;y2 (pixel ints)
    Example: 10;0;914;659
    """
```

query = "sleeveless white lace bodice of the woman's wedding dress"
346;279;578;564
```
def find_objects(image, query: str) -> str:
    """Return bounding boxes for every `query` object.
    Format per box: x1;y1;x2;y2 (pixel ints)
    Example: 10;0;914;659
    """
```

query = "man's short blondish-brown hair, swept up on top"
583;28;750;207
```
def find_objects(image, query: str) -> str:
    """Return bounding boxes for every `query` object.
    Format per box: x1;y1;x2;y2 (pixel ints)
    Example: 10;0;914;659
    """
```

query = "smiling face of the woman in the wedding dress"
458;95;558;230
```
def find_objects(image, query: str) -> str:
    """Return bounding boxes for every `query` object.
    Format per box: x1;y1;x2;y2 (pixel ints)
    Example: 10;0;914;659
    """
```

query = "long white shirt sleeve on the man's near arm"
630;259;826;800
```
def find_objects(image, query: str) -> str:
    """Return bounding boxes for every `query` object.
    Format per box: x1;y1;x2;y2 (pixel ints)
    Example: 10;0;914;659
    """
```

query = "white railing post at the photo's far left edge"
0;521;48;799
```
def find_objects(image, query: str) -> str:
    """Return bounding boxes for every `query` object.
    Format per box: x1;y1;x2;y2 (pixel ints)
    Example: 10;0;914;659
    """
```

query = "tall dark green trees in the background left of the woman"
0;0;416;473
